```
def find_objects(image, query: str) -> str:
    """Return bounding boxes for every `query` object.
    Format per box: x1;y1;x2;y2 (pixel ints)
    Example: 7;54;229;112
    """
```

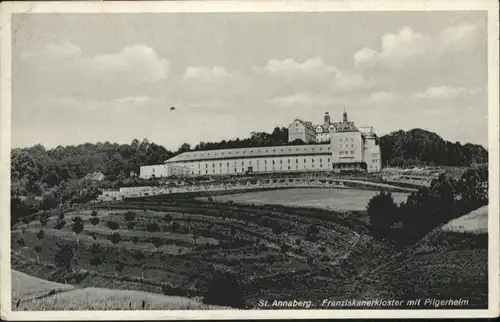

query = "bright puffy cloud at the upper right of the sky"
354;23;479;68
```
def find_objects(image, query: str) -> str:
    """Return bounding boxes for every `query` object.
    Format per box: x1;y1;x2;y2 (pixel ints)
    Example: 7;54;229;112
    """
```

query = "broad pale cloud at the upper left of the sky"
18;41;170;100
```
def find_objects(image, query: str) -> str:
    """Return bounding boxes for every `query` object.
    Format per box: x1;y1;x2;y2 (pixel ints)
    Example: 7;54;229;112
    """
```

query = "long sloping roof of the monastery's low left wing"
165;144;332;163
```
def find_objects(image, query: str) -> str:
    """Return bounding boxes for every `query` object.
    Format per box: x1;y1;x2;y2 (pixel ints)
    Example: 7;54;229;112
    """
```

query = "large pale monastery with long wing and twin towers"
140;111;382;179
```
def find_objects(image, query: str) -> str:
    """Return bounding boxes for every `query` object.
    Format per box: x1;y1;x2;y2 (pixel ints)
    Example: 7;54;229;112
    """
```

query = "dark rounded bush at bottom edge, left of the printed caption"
203;273;245;309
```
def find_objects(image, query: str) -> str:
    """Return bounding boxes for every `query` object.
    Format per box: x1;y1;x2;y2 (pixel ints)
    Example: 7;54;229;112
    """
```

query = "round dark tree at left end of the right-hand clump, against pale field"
366;191;398;236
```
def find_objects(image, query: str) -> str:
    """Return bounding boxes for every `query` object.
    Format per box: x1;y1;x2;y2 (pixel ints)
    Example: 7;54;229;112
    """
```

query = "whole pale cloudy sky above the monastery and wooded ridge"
11;11;488;150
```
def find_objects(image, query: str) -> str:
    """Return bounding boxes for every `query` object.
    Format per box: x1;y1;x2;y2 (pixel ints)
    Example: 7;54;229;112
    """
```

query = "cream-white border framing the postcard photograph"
0;0;500;321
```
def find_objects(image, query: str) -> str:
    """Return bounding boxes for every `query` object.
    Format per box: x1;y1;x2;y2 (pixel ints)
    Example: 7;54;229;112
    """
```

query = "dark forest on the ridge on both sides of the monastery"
11;127;488;219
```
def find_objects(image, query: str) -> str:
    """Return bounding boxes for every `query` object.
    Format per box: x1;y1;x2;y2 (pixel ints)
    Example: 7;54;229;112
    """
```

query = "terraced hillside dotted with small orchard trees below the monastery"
12;190;391;307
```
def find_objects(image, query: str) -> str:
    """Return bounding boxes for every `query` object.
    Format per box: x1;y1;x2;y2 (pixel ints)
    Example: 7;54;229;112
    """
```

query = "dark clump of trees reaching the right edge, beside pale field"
367;166;488;245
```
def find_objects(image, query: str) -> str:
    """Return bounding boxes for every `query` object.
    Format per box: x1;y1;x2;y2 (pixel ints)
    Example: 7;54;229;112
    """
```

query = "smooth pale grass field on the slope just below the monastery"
205;188;408;211
